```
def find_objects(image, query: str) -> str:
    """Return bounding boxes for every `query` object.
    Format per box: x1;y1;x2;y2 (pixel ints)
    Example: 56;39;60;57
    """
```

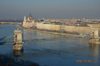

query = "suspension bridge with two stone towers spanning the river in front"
0;30;100;50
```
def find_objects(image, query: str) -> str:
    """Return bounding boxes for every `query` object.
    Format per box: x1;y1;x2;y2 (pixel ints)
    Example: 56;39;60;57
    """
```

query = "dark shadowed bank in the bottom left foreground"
0;54;39;66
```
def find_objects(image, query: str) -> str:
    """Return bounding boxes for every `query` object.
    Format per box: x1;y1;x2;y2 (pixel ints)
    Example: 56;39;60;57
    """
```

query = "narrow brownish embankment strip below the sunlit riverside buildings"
18;25;76;36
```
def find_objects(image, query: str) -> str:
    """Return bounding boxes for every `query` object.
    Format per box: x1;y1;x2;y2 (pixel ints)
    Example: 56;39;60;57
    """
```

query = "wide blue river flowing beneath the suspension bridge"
0;24;100;66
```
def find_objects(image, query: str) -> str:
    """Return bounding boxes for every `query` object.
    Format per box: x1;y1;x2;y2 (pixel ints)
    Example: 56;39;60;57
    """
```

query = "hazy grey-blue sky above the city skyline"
0;0;100;19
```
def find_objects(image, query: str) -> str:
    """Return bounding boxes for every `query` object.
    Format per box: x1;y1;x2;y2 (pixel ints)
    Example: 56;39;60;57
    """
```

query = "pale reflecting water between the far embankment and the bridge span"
23;30;61;40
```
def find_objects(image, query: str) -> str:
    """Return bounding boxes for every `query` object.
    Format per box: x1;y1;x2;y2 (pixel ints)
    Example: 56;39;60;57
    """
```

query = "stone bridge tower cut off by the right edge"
89;30;100;44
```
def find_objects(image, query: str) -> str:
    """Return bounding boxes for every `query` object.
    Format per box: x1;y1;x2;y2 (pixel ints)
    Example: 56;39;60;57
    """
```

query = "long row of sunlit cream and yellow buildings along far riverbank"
37;23;98;34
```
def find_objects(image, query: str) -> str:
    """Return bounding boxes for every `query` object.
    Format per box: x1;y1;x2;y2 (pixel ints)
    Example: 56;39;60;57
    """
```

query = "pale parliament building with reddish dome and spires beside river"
23;14;35;28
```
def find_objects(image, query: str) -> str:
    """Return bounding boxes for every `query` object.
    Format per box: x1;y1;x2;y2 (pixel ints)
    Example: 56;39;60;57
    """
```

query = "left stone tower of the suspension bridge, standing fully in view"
13;30;24;50
